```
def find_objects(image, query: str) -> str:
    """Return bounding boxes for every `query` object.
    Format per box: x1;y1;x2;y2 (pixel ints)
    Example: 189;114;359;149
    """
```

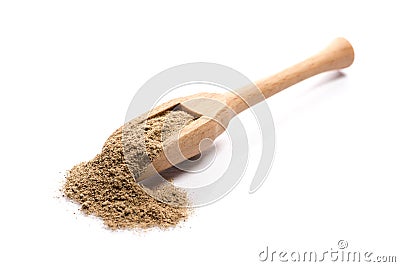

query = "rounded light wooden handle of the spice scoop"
226;38;354;113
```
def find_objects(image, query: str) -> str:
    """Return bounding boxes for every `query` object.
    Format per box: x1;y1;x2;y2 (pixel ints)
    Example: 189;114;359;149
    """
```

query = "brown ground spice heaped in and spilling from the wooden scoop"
62;111;194;229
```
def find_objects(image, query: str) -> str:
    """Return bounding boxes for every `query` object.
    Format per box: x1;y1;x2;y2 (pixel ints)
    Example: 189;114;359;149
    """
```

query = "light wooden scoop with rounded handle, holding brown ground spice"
136;38;354;182
